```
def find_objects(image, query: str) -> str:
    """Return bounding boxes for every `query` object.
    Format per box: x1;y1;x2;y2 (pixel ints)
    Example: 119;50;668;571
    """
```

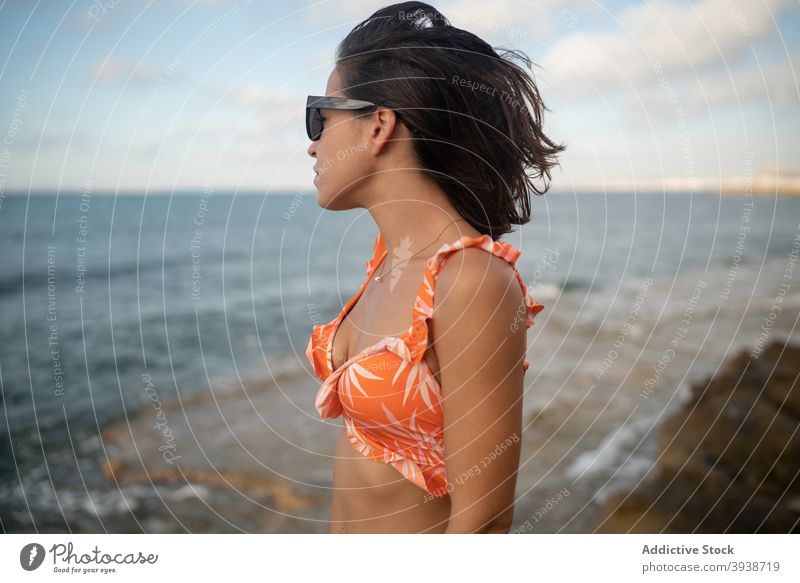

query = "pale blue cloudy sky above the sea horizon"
0;0;800;196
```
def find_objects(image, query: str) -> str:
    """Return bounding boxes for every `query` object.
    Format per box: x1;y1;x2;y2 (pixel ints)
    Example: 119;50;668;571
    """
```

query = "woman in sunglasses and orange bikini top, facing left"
306;2;562;533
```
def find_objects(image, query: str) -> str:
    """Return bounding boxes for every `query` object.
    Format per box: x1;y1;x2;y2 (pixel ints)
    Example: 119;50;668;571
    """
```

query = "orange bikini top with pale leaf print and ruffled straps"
306;232;544;496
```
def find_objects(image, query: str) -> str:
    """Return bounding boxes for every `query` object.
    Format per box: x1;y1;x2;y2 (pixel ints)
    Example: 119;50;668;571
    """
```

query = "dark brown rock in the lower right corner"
593;341;800;533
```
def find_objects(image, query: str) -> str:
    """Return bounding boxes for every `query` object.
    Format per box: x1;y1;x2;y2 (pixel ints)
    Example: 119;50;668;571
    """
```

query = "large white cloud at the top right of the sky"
542;0;789;96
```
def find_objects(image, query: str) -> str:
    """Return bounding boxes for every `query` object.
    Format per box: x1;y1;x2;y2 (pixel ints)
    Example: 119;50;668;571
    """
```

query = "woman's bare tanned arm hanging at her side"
431;249;526;533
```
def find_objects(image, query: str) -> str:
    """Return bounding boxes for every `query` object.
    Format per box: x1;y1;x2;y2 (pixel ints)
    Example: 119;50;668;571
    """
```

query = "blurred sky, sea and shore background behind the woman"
0;0;800;533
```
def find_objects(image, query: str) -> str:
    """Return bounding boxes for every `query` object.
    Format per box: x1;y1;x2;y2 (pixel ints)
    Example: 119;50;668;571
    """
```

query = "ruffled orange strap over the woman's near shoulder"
407;235;544;362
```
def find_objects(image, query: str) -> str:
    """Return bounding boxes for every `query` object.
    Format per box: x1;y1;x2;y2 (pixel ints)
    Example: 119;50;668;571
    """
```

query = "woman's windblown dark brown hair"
336;2;564;240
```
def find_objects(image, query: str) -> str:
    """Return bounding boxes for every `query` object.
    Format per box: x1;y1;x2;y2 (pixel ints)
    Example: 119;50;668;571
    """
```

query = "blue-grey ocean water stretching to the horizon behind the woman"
0;192;800;529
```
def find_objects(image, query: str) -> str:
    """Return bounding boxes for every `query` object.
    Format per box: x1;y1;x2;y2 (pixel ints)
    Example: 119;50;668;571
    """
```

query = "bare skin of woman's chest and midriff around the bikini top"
330;252;450;533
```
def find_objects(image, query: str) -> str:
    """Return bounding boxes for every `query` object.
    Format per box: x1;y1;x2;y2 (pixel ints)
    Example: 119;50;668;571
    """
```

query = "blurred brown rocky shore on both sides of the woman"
101;341;800;533
